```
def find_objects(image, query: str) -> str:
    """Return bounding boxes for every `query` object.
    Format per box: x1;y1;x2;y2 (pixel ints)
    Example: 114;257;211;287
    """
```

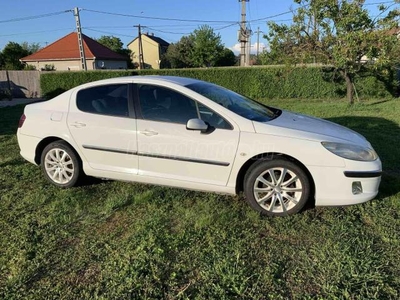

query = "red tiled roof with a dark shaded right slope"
21;32;127;61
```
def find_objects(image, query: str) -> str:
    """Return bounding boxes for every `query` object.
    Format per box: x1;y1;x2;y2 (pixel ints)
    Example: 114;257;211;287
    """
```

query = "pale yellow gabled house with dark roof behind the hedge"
128;33;169;69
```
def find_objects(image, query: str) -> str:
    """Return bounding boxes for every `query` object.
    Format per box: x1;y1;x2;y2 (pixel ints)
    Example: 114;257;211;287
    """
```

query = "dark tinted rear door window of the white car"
76;84;129;117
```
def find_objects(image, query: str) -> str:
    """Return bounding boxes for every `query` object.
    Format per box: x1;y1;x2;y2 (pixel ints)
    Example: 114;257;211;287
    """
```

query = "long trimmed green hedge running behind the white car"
40;67;397;99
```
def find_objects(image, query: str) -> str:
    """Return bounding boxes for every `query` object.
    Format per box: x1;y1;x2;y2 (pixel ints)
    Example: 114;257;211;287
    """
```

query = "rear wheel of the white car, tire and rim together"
40;141;83;188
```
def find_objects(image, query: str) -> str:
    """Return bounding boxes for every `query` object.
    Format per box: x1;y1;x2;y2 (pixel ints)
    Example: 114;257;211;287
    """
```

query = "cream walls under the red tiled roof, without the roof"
27;59;128;71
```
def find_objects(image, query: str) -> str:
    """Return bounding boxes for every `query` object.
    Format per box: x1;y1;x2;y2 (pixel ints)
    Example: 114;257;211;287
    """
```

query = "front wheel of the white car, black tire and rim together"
244;159;310;216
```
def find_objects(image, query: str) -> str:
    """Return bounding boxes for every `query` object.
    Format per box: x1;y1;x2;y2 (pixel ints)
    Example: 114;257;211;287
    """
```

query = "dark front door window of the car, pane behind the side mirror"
139;85;198;124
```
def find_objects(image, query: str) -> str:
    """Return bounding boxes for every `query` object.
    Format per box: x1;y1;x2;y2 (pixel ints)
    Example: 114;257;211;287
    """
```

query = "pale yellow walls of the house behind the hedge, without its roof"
128;34;161;69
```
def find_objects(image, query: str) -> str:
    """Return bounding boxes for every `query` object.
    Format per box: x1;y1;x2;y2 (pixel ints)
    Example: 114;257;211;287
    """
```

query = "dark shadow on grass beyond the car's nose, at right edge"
327;116;400;197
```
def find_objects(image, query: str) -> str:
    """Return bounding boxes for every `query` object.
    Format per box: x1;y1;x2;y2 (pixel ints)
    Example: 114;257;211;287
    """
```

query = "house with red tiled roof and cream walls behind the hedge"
20;32;128;71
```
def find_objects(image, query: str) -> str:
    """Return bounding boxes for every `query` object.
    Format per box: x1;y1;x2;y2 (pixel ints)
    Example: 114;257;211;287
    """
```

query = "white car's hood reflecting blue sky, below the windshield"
253;111;370;146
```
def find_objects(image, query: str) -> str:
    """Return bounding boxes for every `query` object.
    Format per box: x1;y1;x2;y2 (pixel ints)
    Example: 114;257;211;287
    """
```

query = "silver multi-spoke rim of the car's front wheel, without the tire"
254;168;303;213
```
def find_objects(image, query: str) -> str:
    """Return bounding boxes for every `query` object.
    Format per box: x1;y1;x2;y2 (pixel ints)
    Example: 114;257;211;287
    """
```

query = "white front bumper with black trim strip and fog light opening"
309;159;382;206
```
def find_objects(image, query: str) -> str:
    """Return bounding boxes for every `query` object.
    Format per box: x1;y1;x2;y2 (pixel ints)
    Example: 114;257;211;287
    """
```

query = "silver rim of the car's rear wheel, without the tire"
44;148;75;184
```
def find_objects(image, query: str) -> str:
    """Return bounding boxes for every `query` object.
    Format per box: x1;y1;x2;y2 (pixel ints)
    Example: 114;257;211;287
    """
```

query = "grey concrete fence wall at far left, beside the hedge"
0;71;41;98
